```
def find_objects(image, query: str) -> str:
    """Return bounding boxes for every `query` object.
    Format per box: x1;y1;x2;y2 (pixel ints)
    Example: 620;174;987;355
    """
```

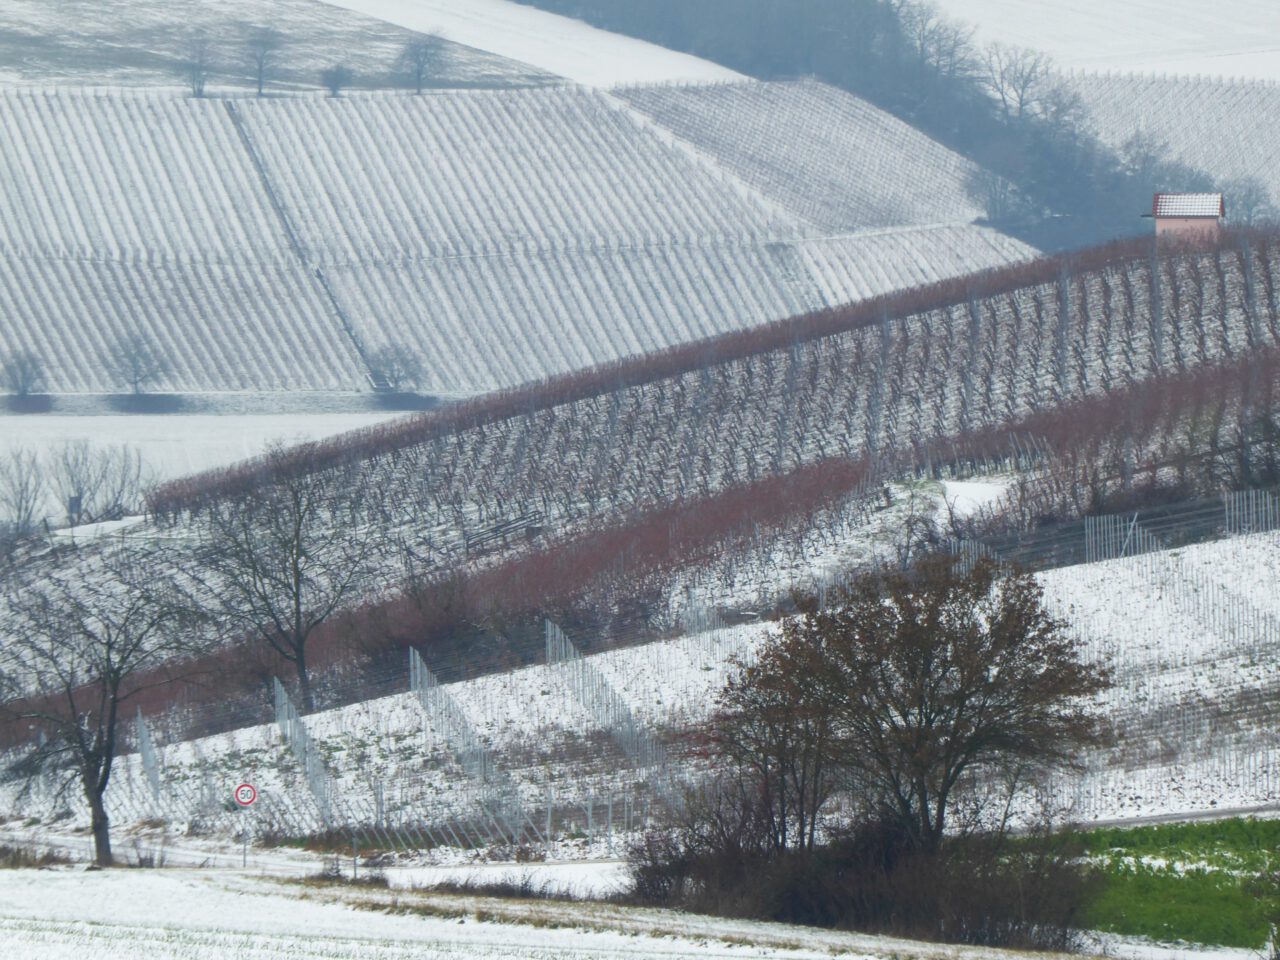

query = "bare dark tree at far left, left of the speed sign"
0;550;207;867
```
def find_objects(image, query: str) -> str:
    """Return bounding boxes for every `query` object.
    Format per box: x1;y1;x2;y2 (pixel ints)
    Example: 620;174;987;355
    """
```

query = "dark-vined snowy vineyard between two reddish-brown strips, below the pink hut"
5;236;1280;727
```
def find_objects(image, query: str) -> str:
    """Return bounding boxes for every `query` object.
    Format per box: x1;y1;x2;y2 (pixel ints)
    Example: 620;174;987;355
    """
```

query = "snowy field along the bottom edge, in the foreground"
0;870;1100;960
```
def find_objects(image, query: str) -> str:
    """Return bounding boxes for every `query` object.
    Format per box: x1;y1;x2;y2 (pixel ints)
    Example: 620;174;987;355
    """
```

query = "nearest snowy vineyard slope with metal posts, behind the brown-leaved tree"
10;502;1280;846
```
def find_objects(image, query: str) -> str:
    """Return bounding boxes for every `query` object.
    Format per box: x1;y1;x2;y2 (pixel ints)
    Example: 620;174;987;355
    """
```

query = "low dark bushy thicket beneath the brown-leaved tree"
630;822;1098;950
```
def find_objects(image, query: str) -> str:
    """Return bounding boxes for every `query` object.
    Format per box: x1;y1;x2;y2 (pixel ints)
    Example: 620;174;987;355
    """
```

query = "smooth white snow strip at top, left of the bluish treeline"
314;0;744;87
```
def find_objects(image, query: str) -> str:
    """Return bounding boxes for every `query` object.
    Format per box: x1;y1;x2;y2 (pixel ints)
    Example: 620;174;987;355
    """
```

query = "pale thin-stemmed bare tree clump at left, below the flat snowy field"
45;440;152;524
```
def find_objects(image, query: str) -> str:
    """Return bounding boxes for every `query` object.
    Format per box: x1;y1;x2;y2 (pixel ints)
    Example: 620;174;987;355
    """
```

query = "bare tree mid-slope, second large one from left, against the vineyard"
205;447;375;710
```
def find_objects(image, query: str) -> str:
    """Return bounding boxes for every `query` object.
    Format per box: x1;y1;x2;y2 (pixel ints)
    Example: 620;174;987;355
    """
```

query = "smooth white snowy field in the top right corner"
937;0;1280;79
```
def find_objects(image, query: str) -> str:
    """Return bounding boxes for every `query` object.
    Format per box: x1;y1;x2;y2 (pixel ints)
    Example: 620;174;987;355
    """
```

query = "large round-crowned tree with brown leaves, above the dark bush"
786;557;1110;852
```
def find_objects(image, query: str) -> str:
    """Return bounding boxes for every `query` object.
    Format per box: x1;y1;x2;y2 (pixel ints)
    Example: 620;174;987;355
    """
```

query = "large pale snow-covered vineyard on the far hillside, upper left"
0;84;1033;394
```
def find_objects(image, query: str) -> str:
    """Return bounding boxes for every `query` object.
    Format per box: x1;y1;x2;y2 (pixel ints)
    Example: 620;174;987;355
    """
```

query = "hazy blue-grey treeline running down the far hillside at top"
521;0;1213;250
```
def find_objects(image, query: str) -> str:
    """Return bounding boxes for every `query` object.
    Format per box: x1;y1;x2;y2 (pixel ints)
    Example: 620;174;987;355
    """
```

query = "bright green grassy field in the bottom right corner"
1078;819;1280;948
